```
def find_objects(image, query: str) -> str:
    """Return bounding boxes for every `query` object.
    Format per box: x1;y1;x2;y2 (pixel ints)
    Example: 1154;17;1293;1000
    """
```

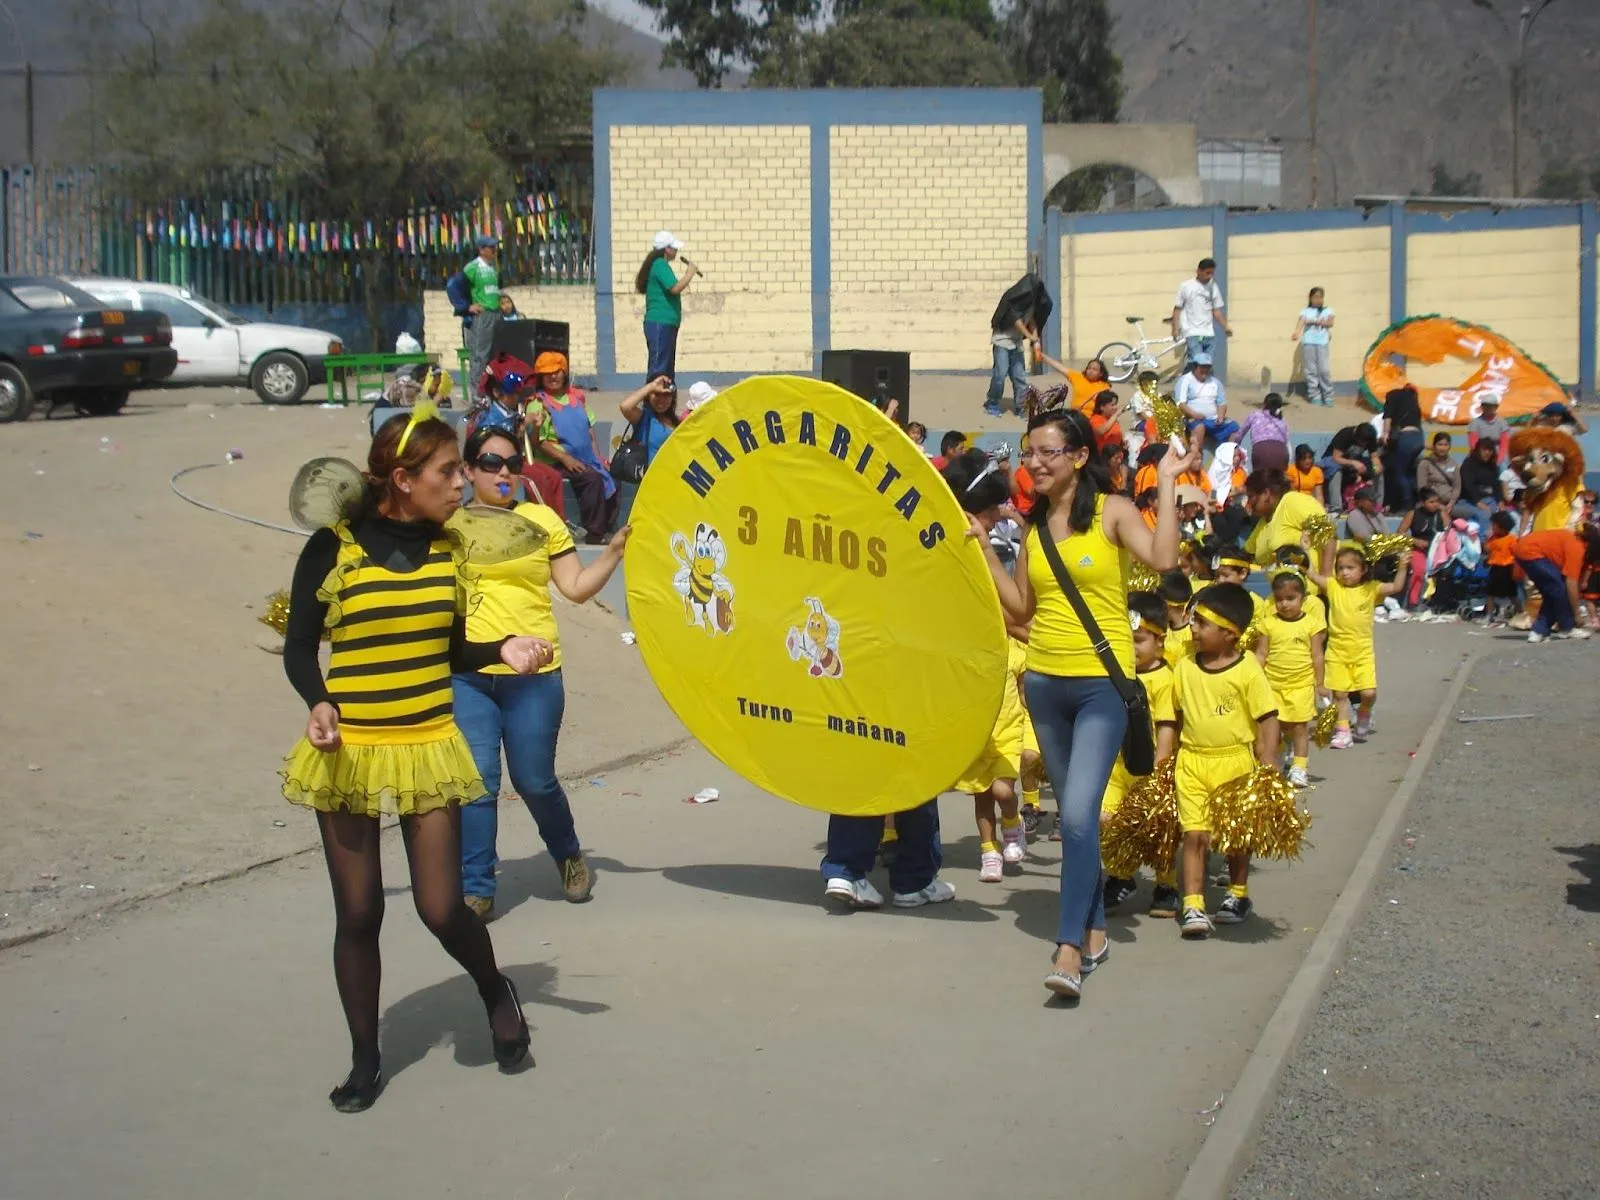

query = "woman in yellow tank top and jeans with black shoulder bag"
973;410;1198;998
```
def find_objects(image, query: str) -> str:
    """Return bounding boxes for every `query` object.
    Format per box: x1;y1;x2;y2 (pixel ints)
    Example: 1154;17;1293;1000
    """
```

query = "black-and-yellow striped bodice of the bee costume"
328;533;456;746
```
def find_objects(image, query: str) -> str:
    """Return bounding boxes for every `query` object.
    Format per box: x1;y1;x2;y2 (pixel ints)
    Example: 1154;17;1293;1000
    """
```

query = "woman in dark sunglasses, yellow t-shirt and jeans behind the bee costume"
454;429;629;920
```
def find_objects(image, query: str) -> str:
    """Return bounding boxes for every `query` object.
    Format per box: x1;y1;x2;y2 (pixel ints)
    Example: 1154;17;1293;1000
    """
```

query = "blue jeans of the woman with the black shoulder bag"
1022;670;1128;950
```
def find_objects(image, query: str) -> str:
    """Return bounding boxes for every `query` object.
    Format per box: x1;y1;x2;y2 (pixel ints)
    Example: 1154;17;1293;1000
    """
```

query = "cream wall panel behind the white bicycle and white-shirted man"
1056;222;1209;370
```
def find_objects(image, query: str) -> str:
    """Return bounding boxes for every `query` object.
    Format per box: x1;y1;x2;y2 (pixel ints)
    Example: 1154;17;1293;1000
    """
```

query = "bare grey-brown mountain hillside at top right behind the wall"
1112;0;1600;206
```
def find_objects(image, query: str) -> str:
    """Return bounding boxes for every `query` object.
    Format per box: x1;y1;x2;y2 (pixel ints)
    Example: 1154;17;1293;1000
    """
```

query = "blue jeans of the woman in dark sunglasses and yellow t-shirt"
453;670;578;896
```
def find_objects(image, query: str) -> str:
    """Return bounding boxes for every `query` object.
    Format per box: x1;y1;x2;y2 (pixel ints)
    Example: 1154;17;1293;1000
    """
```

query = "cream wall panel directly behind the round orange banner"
1406;224;1581;387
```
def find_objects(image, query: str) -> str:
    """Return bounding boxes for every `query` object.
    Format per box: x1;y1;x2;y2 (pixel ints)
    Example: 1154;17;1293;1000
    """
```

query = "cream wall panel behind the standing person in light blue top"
1222;224;1389;384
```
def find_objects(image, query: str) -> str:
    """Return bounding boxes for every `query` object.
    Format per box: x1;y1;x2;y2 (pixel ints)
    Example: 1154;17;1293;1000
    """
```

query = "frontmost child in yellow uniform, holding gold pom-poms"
1173;584;1278;938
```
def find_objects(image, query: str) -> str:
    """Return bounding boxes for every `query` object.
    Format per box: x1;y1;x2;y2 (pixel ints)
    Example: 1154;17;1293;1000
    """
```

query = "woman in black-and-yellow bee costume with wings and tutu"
282;406;554;1112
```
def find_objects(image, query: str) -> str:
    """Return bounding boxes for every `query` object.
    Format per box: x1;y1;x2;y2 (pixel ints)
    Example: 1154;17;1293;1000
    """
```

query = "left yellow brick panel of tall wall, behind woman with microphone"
611;125;813;378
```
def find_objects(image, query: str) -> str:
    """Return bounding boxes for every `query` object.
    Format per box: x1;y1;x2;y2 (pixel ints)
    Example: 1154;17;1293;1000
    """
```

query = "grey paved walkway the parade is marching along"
0;627;1465;1200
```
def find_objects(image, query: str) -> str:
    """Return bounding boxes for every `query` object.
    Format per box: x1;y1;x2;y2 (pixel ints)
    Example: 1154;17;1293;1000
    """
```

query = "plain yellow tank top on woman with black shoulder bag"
1027;496;1133;677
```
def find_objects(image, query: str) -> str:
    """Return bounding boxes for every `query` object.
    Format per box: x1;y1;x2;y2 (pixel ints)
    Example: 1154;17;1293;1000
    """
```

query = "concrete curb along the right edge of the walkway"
1173;653;1483;1200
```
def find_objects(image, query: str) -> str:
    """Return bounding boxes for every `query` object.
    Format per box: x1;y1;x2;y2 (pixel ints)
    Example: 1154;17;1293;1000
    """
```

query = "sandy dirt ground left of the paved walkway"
0;389;683;944
